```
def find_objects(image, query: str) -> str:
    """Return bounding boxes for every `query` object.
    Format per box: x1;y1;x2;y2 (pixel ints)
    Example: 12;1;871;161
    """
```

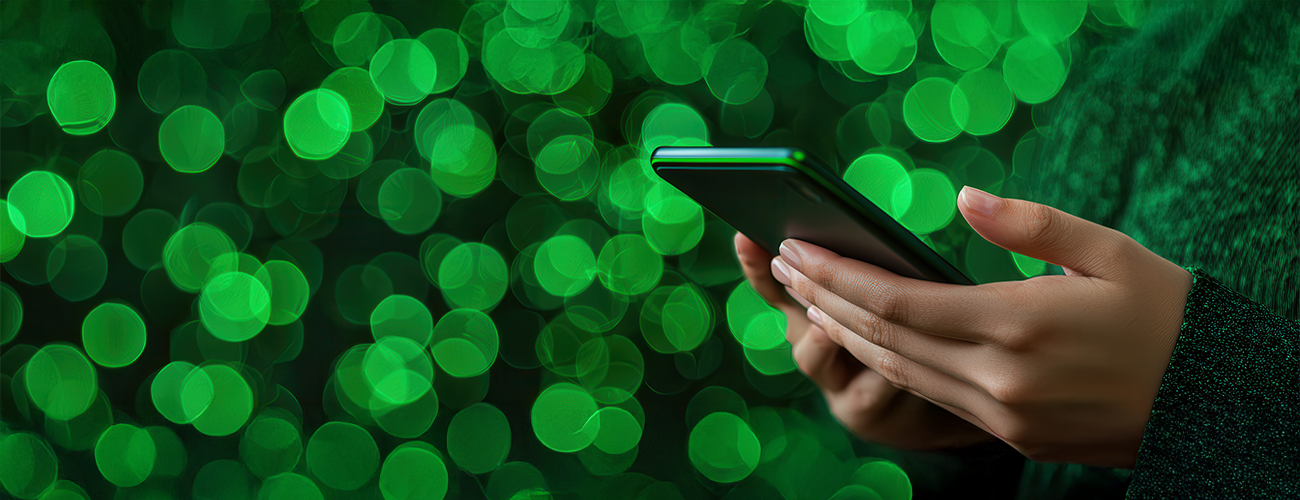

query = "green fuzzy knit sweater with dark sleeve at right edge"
1019;0;1300;499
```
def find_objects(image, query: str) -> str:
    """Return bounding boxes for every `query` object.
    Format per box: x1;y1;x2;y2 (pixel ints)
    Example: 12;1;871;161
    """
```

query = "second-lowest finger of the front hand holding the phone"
807;295;987;386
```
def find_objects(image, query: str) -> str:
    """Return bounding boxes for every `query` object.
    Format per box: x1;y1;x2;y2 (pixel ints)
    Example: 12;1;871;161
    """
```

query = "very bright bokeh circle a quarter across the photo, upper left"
285;88;352;160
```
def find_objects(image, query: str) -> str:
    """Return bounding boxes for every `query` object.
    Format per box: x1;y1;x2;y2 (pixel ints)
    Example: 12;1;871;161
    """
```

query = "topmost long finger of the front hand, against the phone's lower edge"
774;249;1003;343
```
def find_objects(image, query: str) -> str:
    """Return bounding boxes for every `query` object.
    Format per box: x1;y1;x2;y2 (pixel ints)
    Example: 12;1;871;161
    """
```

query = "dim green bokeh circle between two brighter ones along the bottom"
447;403;511;474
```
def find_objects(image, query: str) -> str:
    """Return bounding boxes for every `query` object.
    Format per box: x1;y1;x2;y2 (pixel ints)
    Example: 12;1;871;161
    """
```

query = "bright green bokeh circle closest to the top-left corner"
46;61;117;135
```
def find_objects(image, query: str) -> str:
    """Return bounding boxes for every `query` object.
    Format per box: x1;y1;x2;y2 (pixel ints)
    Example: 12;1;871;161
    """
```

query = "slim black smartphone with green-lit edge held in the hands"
650;147;975;284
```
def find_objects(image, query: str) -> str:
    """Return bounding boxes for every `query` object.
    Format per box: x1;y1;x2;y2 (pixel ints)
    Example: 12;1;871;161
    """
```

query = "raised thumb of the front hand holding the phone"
957;186;1136;278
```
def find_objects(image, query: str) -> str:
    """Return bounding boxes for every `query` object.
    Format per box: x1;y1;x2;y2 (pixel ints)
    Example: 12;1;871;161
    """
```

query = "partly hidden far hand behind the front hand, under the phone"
736;234;993;449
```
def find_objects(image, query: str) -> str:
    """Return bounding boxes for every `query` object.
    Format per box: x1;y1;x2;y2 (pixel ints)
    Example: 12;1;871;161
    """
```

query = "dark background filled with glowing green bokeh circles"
0;0;1147;500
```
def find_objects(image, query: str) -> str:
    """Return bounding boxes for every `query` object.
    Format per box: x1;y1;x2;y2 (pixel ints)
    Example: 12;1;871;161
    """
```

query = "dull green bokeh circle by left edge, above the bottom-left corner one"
26;344;99;421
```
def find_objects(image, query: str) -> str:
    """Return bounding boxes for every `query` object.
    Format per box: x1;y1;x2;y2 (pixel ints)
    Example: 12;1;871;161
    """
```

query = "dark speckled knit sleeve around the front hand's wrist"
1128;268;1300;499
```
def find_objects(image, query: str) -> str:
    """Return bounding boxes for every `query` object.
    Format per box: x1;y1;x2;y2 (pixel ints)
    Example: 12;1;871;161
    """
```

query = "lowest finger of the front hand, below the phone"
809;306;988;413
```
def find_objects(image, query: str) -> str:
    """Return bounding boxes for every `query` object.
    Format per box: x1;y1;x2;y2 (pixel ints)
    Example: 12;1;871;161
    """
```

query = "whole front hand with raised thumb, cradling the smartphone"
772;187;1191;468
